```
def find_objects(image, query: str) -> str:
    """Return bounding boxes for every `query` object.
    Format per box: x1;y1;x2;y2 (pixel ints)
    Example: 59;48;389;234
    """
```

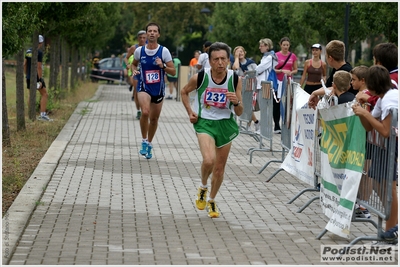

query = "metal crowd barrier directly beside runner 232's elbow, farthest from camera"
238;71;262;141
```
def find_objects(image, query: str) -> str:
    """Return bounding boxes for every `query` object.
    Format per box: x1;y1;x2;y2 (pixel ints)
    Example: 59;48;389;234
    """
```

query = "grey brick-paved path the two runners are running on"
3;85;397;265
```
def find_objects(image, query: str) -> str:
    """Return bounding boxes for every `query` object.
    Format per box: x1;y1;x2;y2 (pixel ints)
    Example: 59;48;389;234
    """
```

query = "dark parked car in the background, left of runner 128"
90;57;124;83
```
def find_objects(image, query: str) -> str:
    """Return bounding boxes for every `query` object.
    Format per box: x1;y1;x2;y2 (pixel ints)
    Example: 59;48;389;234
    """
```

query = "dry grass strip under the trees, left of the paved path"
2;68;99;216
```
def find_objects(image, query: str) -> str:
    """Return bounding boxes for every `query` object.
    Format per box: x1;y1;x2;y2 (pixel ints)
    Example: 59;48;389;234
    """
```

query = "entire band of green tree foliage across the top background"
2;2;398;66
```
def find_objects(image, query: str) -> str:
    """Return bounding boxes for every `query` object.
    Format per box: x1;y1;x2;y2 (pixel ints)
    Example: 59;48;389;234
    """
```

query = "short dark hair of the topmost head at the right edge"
372;43;398;71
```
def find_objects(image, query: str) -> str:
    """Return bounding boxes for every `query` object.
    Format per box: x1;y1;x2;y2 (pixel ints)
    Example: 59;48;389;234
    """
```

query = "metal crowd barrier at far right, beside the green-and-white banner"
317;108;398;246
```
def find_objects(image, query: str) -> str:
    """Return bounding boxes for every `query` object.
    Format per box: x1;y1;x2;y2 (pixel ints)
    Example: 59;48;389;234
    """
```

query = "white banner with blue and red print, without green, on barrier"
281;86;317;185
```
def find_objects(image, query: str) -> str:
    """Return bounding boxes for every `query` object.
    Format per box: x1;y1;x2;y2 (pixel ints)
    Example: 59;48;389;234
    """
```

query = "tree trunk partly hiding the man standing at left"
28;31;39;121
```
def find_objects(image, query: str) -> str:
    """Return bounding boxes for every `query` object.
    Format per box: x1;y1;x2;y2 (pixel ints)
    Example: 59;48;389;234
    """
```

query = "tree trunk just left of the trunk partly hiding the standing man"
16;48;26;131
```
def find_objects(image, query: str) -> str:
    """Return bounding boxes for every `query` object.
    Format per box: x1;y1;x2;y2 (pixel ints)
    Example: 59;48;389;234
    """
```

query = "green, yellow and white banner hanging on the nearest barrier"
319;103;366;238
